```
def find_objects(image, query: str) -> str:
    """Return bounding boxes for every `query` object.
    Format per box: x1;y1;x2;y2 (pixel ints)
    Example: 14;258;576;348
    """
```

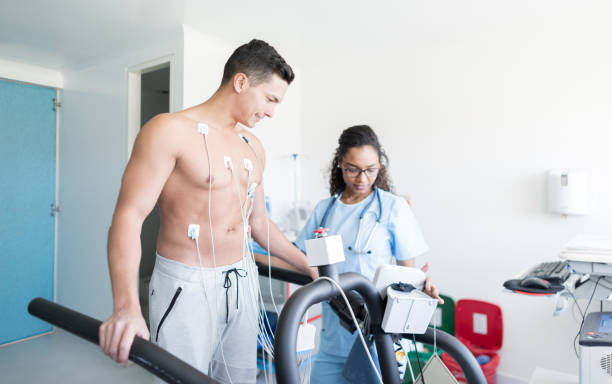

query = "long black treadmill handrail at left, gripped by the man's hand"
28;297;218;384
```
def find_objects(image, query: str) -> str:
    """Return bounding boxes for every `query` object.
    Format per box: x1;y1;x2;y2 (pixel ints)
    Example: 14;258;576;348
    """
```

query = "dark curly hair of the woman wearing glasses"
329;125;393;196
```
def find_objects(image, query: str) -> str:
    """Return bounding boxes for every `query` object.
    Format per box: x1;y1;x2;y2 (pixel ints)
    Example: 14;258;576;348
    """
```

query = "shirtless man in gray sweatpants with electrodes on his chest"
99;40;312;383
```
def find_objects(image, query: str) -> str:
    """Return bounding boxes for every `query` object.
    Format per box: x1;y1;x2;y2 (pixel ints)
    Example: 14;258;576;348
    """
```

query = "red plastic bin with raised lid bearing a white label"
441;299;503;384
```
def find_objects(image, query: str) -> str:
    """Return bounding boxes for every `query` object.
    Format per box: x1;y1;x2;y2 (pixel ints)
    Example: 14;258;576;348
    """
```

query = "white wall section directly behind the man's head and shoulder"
183;25;301;228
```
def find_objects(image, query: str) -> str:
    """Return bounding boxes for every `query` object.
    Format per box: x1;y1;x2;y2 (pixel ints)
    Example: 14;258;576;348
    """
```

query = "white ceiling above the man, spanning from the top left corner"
0;0;454;70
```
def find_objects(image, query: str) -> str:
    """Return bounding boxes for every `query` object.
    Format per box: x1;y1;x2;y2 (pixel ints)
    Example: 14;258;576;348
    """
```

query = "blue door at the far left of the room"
0;80;56;345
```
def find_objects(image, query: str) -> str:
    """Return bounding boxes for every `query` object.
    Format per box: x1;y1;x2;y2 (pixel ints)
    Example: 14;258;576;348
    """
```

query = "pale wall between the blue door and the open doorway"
57;27;183;319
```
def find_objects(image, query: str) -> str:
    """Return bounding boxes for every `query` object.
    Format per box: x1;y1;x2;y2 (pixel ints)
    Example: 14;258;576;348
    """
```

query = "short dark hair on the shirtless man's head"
221;39;295;85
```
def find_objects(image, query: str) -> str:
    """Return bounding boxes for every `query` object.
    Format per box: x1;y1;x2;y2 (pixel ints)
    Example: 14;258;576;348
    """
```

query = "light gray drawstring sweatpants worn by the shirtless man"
149;254;258;384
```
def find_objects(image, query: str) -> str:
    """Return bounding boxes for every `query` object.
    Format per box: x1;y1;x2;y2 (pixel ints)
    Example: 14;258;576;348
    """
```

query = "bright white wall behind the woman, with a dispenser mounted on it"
300;0;612;381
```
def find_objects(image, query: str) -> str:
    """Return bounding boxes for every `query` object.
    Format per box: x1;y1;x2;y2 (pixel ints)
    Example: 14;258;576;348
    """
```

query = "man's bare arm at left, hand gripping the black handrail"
99;115;177;364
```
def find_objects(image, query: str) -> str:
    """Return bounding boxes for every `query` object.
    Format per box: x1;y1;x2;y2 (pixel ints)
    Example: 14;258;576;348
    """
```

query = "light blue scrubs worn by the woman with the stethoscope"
296;189;429;357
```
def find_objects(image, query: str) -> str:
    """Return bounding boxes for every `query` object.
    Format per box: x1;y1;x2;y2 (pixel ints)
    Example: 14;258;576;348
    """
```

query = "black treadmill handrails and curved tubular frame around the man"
28;263;486;384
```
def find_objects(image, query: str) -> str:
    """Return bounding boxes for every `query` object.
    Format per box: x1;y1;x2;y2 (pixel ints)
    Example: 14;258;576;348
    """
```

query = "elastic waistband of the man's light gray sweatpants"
154;252;257;283
